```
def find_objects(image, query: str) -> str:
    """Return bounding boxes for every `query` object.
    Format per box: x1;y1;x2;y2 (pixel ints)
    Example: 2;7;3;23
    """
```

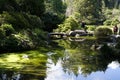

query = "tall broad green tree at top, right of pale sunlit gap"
75;0;102;24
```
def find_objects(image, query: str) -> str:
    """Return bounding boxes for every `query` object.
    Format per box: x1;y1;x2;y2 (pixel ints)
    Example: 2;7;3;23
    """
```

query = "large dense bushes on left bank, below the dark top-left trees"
0;12;46;51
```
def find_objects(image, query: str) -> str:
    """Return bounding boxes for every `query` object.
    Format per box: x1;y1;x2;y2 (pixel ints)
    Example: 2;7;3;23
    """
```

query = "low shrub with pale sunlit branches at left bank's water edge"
5;33;34;50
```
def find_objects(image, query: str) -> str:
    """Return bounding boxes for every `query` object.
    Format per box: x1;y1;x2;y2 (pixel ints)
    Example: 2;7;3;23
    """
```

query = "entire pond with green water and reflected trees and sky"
0;39;120;80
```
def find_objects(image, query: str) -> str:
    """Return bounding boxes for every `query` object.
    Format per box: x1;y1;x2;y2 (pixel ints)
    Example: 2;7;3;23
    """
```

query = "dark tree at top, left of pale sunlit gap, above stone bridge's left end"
42;0;66;32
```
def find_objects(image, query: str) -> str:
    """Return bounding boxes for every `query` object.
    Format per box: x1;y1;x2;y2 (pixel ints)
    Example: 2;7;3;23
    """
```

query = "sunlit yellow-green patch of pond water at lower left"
0;50;47;80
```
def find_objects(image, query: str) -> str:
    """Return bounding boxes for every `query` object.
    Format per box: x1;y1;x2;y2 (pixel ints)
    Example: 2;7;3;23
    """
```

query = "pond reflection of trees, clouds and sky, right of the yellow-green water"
46;40;120;80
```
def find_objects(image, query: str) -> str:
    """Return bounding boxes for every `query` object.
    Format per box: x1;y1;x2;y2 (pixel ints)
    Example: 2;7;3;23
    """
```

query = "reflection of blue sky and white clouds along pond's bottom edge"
45;52;120;80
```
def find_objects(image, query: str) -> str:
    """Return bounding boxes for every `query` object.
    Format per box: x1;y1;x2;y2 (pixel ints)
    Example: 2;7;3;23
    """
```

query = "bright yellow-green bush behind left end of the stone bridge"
55;17;79;32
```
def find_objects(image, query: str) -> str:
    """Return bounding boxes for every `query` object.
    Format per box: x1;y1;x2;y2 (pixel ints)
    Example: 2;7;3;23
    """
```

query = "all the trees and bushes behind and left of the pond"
0;0;120;51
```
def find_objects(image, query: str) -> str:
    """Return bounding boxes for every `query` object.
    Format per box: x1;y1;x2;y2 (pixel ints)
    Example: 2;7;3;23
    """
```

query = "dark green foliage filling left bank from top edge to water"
0;0;45;51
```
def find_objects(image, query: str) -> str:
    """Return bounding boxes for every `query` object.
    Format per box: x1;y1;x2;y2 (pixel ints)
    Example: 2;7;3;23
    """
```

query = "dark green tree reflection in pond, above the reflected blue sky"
57;40;120;76
